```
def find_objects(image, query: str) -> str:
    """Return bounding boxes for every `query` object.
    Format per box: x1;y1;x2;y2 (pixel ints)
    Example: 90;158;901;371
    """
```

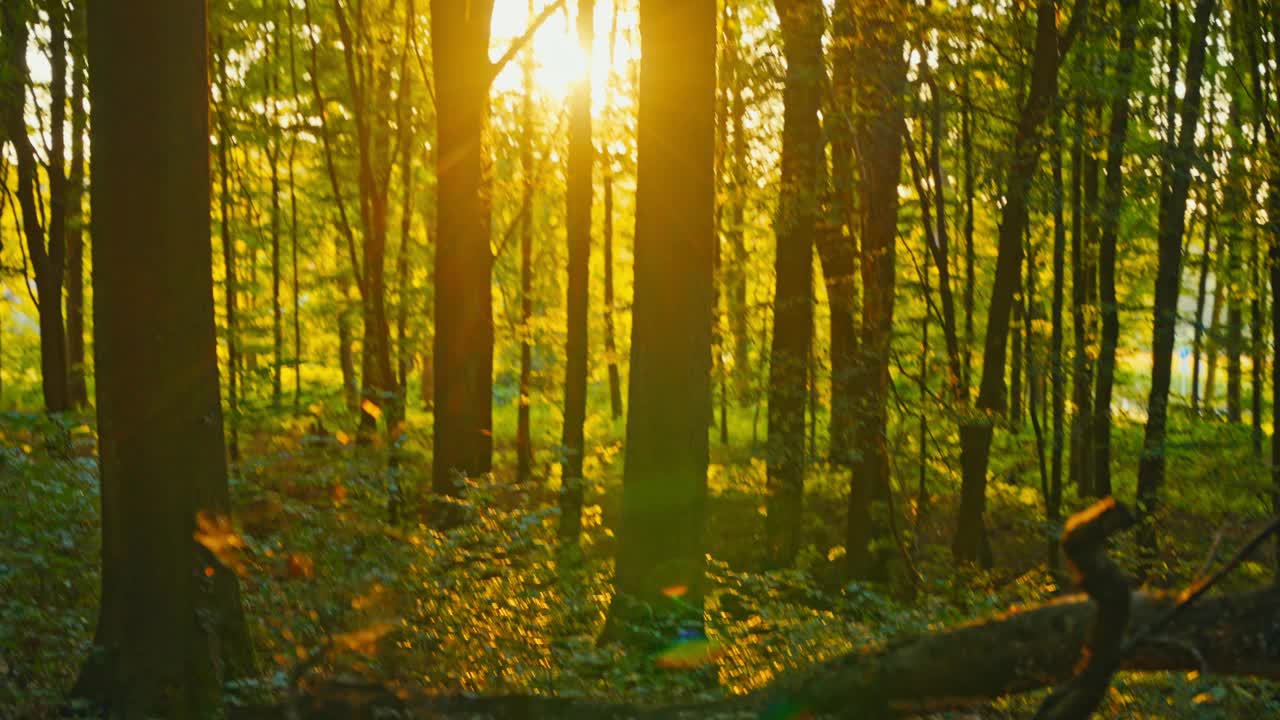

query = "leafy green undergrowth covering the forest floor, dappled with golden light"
0;394;1280;719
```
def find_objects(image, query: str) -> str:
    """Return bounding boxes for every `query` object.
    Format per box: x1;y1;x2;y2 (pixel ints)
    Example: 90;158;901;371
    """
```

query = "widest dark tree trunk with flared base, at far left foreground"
74;0;251;717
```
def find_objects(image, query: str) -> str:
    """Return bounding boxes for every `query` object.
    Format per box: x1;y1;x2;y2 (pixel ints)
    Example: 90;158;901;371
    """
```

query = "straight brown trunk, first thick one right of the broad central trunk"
765;0;826;566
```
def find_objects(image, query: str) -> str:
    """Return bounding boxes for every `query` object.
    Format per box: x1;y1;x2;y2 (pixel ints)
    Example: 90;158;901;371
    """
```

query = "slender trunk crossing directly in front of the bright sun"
559;0;595;544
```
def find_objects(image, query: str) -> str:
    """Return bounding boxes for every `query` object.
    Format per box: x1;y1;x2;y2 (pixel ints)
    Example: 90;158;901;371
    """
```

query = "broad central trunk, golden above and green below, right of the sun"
605;0;716;637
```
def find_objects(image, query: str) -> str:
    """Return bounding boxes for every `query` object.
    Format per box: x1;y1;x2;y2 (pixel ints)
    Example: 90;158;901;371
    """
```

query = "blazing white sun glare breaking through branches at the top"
489;0;639;111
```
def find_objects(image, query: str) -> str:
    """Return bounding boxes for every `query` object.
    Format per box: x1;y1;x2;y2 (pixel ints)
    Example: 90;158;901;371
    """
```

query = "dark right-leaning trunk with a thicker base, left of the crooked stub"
952;0;1059;564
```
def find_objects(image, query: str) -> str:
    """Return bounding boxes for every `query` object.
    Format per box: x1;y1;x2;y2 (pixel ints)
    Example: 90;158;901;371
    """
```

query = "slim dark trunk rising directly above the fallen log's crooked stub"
1093;0;1139;497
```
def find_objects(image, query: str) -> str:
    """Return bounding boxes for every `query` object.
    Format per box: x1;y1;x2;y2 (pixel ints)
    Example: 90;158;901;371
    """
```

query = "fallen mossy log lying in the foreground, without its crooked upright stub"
230;588;1280;720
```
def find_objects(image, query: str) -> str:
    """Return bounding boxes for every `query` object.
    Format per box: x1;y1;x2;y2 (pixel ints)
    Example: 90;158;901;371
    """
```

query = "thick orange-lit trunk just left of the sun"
431;0;493;495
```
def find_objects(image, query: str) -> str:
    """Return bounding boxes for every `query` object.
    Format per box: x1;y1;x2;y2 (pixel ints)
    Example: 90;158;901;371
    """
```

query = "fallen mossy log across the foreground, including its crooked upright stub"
230;500;1280;720
